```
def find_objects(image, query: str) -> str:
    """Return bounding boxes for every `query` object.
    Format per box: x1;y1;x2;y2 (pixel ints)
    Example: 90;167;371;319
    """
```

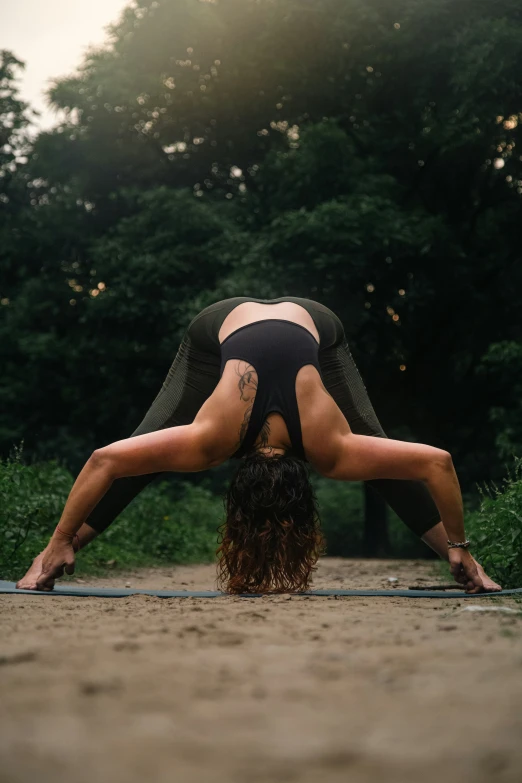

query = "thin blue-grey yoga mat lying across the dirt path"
0;580;522;598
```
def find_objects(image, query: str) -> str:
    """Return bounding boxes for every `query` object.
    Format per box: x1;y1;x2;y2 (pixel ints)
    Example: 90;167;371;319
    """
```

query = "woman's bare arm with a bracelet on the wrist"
325;433;483;592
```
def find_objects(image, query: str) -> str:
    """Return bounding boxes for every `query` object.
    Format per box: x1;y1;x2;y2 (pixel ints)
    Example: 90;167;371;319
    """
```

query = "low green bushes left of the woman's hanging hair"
0;449;223;579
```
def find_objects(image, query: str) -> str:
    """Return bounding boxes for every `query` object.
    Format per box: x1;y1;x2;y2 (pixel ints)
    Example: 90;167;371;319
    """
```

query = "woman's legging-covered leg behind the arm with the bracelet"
320;333;440;540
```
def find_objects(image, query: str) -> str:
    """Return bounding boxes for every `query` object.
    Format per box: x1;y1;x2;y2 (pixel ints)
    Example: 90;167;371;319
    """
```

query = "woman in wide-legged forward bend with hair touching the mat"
17;296;501;593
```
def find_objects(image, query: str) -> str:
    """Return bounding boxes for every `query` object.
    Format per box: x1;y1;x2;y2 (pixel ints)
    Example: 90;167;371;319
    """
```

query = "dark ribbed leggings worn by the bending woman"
86;296;440;537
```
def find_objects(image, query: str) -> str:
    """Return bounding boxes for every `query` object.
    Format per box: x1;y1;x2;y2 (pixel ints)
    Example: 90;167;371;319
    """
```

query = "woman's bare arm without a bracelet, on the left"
36;421;217;590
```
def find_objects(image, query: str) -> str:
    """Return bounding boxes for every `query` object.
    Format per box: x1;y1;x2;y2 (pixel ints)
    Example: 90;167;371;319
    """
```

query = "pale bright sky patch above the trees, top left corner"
0;0;131;128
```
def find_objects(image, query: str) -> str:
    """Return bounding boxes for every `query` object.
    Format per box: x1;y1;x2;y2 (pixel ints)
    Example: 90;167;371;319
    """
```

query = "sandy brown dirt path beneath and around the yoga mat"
0;558;522;783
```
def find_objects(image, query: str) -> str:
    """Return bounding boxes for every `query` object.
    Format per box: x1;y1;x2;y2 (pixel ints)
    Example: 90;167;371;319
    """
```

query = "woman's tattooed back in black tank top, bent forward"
192;302;349;470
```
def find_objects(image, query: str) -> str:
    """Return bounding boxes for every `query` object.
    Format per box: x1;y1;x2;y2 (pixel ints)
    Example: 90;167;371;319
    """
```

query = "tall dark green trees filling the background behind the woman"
0;0;522;564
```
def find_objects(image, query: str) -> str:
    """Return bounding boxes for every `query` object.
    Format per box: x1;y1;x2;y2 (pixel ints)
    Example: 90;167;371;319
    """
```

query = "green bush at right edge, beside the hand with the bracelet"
466;457;522;589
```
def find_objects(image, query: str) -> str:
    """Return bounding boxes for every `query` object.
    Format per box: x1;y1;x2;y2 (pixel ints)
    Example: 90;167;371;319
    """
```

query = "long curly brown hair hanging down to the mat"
216;452;324;593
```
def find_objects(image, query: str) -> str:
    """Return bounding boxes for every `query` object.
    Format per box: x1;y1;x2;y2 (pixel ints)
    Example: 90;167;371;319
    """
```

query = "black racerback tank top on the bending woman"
216;318;321;461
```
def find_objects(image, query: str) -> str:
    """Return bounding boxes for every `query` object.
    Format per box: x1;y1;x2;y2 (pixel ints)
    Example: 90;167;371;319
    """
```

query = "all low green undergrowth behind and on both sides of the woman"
4;446;522;601
